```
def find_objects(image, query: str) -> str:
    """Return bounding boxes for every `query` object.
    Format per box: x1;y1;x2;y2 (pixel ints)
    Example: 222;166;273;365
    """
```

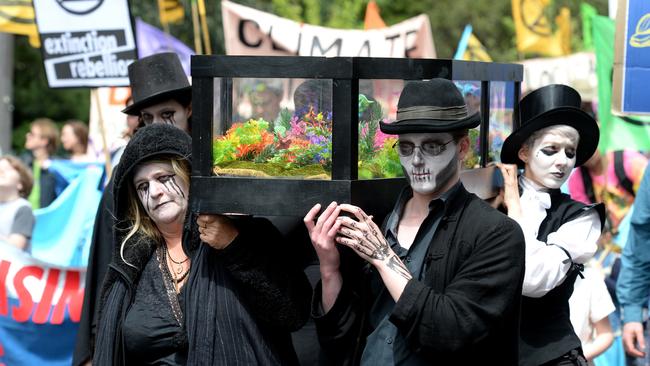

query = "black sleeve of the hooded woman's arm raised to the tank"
218;218;311;331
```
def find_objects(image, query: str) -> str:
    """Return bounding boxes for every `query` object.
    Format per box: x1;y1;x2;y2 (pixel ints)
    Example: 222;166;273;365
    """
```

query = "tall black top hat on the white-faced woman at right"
501;84;600;167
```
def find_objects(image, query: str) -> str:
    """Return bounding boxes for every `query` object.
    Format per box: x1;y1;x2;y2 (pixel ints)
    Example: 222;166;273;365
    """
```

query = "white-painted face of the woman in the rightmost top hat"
524;133;578;189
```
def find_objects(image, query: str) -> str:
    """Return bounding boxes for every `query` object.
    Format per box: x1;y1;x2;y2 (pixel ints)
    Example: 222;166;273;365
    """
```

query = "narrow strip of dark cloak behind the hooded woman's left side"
72;179;115;366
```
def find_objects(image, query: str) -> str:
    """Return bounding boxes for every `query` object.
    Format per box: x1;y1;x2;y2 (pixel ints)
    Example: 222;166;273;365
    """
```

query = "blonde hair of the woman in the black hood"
120;156;190;267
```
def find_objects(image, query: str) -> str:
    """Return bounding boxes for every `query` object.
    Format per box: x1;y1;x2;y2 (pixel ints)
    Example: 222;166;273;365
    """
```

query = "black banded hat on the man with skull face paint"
379;79;481;135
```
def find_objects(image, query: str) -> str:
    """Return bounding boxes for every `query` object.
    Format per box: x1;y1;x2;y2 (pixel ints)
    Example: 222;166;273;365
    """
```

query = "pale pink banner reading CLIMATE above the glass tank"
221;1;436;58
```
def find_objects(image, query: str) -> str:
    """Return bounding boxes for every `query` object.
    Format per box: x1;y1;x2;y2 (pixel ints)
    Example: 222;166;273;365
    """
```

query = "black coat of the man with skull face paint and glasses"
312;186;525;365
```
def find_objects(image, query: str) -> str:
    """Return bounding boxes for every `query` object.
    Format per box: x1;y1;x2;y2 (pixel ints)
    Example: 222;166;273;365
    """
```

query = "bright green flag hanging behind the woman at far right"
591;15;650;151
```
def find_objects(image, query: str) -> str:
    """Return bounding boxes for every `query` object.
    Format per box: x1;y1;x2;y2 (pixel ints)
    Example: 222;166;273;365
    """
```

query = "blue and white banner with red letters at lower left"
0;241;85;366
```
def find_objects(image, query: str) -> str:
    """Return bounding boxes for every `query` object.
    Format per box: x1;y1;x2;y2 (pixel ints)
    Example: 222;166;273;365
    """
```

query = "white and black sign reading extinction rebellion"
34;0;137;88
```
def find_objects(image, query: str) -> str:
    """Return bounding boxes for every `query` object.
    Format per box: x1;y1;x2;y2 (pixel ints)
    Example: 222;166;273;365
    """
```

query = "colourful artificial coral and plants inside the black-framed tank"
212;95;402;179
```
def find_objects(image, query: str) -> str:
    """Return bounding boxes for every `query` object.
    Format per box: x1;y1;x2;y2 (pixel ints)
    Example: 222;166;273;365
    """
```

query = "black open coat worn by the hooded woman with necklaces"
94;213;311;365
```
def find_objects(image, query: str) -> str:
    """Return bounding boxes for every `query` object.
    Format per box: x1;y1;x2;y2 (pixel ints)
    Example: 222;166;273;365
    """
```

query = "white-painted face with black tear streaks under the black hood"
133;162;189;227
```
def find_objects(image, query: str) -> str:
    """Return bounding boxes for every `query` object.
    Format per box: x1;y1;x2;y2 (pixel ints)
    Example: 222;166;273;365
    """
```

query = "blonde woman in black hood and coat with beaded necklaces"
93;124;311;365
